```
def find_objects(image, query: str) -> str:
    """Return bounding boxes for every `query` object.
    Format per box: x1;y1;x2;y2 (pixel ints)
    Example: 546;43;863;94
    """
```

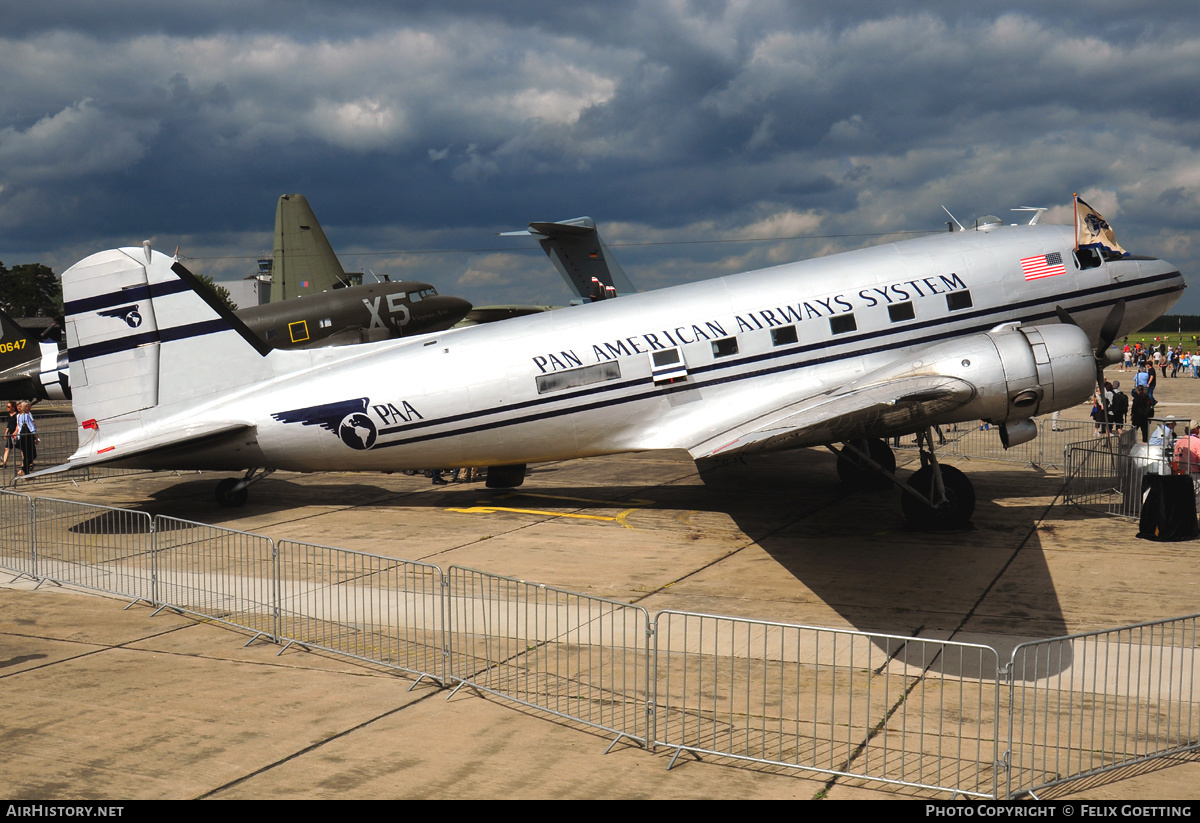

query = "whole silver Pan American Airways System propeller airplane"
34;203;1184;528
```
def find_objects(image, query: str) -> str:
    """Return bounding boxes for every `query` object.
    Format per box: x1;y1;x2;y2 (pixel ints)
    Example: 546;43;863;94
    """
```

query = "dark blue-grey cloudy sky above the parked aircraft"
7;0;1200;313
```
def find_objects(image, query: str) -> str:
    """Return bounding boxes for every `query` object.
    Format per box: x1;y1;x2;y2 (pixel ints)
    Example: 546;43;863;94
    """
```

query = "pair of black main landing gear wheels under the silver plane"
836;428;976;531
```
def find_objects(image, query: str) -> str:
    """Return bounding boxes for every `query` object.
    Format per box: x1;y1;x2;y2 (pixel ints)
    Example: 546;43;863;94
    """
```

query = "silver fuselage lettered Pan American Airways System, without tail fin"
98;226;1183;471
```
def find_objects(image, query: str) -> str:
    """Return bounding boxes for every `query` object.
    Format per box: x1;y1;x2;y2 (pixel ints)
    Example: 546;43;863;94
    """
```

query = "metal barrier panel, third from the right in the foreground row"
446;566;650;745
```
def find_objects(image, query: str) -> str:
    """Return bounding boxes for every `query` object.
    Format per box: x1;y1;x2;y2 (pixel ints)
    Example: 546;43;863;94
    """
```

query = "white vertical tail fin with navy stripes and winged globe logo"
62;244;271;422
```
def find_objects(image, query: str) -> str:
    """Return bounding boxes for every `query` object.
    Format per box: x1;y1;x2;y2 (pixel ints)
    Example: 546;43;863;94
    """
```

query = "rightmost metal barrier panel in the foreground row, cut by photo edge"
1006;614;1200;797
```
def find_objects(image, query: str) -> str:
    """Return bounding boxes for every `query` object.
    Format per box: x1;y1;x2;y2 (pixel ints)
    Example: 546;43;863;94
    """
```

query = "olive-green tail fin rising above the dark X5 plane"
271;194;347;302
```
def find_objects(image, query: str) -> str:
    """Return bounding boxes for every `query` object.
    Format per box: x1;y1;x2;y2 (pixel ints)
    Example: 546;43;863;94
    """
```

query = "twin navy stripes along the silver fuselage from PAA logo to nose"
374;271;1183;449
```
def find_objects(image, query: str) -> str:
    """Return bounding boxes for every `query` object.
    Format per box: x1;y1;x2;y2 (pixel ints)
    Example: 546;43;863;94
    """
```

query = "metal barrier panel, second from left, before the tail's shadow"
30;497;155;601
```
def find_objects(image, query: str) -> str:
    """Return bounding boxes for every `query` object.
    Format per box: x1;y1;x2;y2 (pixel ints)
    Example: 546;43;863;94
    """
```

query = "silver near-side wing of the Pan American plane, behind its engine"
689;374;977;459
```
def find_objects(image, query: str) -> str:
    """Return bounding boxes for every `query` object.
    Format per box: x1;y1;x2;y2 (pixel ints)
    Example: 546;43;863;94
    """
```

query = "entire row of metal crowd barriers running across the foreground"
0;492;1200;797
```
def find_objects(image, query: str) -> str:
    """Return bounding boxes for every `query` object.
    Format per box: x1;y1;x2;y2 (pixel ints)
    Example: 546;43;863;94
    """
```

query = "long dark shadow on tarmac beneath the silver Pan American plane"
103;451;1072;678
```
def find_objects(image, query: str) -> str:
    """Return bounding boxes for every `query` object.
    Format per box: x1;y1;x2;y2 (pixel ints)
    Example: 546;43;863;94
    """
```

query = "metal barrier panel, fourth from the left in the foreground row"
277;540;445;683
